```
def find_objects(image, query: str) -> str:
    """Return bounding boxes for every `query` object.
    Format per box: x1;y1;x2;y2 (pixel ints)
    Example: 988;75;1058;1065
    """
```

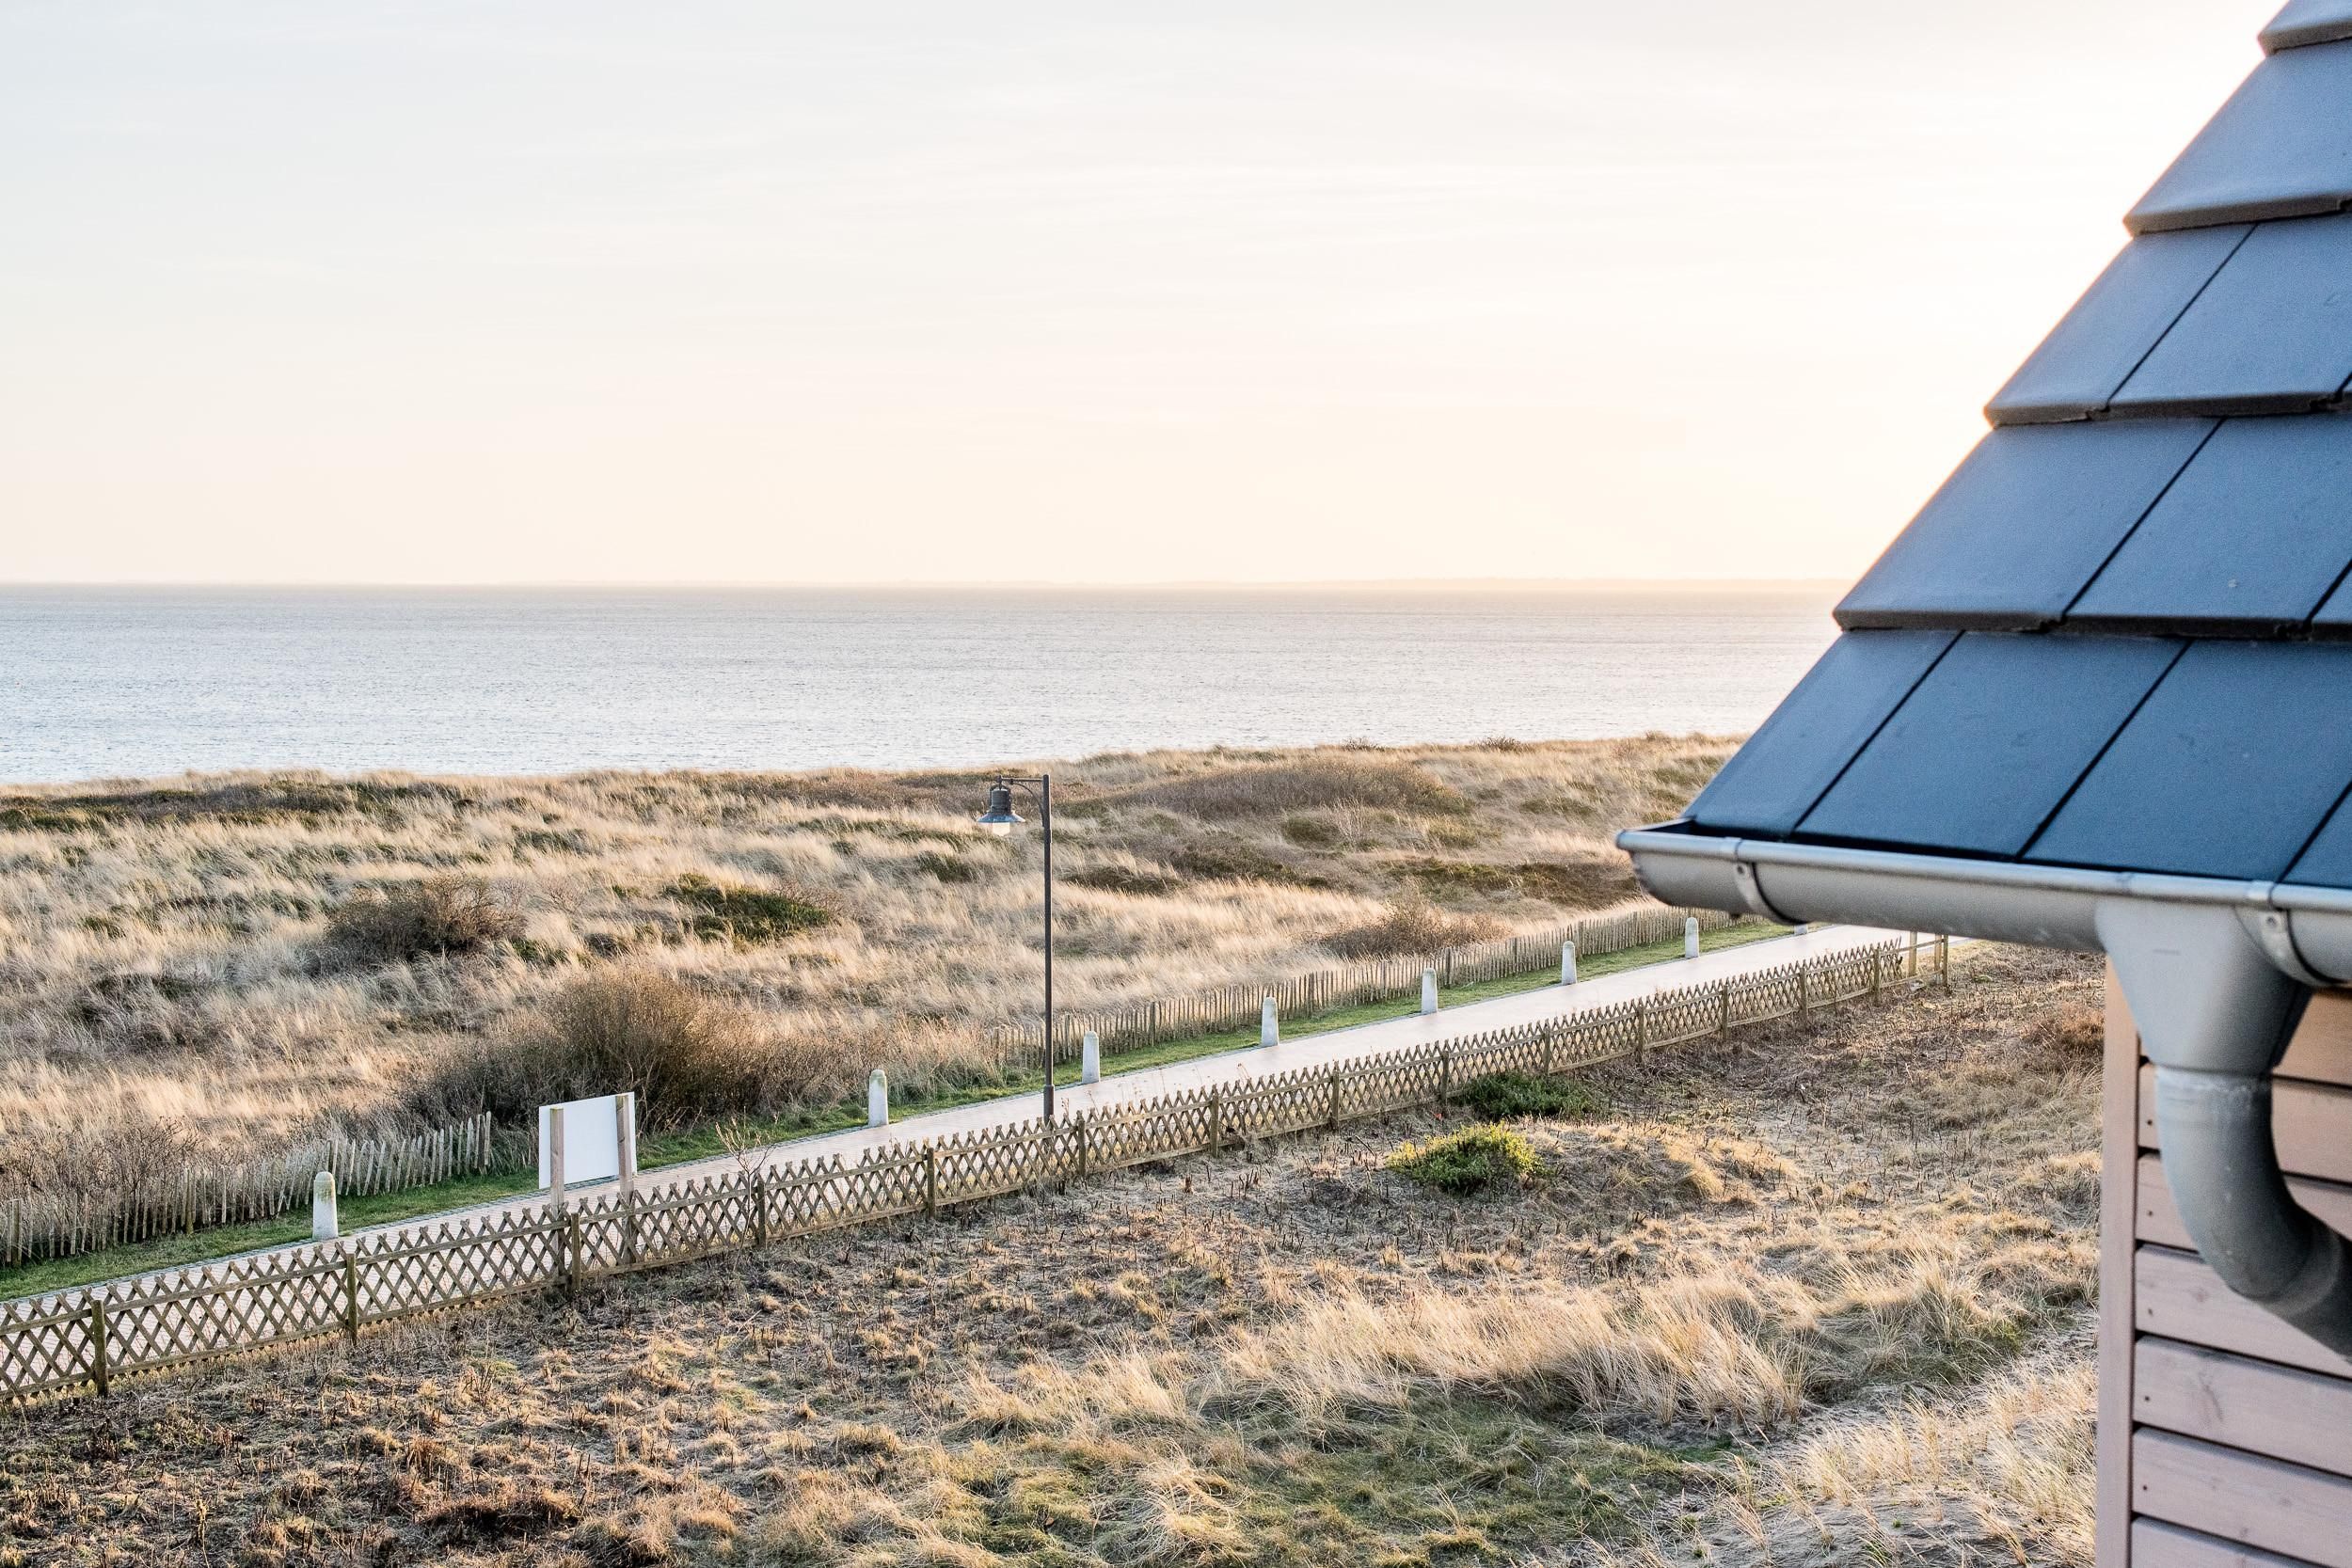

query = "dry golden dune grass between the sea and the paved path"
0;736;1729;1182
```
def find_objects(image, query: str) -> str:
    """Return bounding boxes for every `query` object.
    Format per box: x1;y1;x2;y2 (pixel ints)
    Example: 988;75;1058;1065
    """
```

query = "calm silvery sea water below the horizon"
0;588;1833;783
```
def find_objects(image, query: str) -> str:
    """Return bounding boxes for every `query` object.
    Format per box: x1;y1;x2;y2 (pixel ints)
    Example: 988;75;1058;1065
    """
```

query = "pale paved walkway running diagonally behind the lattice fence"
37;927;1927;1303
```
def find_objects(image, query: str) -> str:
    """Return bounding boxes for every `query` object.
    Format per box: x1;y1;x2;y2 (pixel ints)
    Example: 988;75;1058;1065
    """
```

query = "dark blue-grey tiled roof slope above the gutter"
1687;0;2352;889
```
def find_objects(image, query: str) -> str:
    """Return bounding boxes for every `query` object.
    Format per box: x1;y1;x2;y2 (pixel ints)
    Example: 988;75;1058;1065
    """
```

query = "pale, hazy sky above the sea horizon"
0;0;2275;583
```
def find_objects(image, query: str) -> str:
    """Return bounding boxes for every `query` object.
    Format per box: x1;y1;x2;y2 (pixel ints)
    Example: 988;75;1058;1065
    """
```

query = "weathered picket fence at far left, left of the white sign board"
0;1112;505;1265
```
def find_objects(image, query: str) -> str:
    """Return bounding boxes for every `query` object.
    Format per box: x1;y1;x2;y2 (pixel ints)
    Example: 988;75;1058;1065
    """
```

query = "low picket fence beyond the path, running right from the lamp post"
988;905;1734;1063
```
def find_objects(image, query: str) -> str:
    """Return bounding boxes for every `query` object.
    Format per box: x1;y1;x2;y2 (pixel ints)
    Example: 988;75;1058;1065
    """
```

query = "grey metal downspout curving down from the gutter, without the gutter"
2098;900;2352;1356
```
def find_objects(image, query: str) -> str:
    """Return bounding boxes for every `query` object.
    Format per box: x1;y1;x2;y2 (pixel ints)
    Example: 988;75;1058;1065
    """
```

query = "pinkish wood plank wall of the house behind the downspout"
2098;971;2352;1568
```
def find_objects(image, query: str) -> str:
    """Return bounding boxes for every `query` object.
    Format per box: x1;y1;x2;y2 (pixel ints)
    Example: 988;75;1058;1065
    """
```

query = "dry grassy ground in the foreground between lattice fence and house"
0;950;2098;1568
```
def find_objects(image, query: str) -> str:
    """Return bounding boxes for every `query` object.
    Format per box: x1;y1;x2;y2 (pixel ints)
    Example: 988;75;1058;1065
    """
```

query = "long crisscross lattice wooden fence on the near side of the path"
0;938;1947;1399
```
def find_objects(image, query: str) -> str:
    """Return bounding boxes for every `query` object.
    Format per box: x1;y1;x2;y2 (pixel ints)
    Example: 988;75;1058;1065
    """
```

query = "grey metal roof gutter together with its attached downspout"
1618;825;2352;1356
